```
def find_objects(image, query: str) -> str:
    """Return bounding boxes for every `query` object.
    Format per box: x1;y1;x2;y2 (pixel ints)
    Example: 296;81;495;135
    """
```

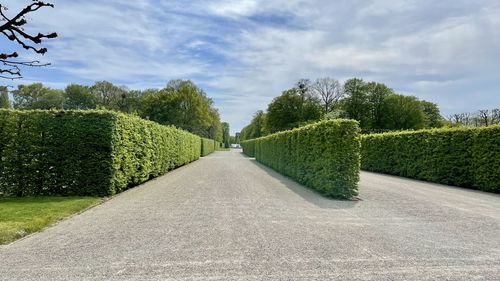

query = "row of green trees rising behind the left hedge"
0;80;229;143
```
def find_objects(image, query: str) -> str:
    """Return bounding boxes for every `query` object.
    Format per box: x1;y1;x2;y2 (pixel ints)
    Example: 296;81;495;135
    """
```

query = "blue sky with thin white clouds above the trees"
0;0;500;133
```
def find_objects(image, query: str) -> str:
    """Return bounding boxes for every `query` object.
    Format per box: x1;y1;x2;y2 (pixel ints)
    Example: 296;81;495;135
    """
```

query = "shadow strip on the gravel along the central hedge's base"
243;154;360;209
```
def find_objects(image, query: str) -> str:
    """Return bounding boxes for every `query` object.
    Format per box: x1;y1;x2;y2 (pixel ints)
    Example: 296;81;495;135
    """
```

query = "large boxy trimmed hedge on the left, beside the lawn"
0;110;200;196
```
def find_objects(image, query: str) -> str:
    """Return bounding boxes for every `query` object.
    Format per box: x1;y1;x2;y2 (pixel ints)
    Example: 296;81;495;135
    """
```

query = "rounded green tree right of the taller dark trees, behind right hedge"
382;94;426;130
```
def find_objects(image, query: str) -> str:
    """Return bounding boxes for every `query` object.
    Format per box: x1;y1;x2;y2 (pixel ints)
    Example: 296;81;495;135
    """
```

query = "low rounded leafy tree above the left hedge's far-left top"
12;83;64;109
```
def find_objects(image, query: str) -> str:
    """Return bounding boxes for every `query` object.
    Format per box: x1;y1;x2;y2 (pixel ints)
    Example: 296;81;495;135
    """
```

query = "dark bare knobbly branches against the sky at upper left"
0;0;57;79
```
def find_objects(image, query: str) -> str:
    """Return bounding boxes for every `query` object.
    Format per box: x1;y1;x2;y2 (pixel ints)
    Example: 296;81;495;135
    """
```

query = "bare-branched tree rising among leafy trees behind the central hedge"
311;77;344;114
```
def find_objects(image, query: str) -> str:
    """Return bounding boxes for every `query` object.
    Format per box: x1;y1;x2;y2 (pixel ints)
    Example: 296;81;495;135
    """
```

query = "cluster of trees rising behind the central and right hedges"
239;77;446;141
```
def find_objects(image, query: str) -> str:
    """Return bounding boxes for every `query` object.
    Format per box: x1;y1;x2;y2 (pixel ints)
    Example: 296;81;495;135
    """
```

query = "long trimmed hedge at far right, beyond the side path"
361;125;500;193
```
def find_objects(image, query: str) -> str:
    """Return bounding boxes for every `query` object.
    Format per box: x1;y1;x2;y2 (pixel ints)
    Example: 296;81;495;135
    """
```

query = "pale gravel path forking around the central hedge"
0;151;500;281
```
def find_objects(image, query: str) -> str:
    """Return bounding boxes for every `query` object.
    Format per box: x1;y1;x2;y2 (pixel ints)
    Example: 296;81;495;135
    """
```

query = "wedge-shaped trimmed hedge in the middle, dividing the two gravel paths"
241;119;360;199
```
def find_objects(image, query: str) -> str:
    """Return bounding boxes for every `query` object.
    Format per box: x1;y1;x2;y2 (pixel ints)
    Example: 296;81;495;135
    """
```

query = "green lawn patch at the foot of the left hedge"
0;197;103;244
